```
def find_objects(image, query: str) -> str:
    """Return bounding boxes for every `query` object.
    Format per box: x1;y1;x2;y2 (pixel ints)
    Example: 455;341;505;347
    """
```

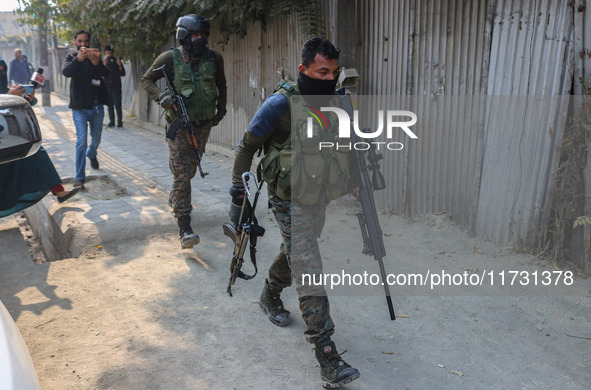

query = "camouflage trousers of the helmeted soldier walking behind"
167;122;211;218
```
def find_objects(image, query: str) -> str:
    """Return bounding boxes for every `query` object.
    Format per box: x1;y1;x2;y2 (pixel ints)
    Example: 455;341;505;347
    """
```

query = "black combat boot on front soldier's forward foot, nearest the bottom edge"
314;341;360;388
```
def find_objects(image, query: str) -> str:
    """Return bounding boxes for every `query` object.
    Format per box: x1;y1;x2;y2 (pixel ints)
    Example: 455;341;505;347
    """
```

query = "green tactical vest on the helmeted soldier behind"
166;47;218;123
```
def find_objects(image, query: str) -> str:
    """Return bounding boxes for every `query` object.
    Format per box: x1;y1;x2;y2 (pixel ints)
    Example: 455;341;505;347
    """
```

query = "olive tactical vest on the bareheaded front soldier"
257;81;350;206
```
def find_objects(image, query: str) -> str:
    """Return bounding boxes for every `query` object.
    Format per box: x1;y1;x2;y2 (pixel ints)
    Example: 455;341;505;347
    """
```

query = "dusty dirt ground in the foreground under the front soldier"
0;198;591;390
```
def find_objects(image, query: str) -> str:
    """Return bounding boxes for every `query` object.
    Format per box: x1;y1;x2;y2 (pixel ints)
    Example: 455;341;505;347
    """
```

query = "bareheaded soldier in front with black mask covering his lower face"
229;37;359;388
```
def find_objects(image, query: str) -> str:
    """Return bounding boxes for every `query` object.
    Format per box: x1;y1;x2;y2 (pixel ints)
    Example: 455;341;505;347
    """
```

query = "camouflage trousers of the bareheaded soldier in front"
269;195;334;344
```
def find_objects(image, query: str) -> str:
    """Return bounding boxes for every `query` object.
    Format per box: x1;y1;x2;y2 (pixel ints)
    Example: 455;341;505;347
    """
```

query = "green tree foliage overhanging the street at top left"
19;0;322;65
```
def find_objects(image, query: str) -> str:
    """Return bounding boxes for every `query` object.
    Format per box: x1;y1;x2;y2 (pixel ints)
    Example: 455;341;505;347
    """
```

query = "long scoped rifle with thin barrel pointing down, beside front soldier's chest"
338;90;396;321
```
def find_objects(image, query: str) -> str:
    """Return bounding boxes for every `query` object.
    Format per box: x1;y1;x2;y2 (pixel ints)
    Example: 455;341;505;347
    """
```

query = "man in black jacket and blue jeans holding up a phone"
62;30;110;187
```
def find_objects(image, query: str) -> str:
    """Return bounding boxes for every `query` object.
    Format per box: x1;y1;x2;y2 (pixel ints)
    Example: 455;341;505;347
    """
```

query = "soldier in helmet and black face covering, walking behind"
141;14;227;248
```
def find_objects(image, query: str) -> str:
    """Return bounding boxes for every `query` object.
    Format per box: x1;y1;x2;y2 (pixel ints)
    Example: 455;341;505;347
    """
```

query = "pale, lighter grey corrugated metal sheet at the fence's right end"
475;0;573;243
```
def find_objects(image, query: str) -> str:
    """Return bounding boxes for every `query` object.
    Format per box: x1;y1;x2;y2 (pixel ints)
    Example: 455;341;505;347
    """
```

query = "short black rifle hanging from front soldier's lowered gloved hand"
222;172;265;296
